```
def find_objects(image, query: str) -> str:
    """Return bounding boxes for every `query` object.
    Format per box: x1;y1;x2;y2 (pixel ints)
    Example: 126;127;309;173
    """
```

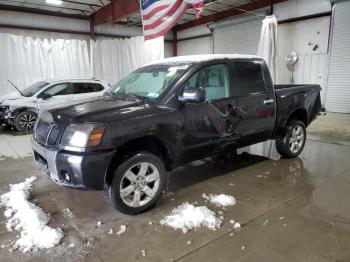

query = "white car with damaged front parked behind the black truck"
0;79;110;131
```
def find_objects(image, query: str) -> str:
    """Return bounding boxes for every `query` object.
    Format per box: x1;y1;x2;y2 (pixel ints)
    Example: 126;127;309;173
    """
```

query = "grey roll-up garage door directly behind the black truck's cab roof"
214;18;262;55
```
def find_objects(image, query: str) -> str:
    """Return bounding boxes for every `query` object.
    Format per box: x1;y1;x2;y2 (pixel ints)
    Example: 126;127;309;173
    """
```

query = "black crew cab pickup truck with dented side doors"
32;55;321;214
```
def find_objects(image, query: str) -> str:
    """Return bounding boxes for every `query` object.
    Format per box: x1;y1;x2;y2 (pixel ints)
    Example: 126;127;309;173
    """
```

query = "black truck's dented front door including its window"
181;63;237;162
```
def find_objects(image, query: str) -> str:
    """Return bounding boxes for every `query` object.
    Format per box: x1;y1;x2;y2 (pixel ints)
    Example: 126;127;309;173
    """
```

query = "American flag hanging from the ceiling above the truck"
140;0;204;40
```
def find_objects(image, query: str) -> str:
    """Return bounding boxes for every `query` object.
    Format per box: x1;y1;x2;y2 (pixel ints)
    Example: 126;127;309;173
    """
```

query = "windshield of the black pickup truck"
110;65;188;100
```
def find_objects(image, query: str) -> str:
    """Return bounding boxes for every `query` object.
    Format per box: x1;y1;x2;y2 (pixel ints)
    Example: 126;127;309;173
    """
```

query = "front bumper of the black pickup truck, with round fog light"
32;138;115;190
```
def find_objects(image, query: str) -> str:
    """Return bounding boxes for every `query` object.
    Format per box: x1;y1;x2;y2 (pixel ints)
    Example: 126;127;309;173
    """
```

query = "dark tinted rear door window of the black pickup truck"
233;62;265;96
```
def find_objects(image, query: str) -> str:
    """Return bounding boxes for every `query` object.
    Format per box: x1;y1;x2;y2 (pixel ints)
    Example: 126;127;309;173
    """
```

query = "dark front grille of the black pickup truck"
34;120;63;146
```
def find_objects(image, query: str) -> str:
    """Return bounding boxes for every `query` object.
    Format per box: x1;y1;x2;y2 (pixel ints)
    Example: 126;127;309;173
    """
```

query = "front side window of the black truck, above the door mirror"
185;64;230;100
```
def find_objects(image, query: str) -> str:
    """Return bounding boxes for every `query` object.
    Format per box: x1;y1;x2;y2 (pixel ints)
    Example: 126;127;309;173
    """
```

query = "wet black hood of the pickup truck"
48;96;145;124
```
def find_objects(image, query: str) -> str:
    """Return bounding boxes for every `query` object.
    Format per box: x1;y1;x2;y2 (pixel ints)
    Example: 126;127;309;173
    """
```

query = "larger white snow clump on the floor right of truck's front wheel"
160;202;222;233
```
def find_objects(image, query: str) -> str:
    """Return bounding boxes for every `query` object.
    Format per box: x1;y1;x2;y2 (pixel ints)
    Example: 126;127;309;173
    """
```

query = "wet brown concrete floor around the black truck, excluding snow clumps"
0;115;350;262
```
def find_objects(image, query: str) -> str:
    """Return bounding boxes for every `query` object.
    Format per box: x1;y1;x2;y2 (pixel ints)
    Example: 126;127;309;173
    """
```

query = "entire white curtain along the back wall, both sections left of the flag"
0;29;164;95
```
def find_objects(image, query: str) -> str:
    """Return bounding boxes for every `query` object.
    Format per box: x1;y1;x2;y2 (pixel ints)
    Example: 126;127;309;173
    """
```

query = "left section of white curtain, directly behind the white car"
0;30;91;95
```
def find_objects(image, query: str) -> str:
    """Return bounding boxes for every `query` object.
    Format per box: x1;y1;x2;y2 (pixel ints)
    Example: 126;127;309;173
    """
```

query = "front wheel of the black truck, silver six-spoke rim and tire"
106;152;166;215
